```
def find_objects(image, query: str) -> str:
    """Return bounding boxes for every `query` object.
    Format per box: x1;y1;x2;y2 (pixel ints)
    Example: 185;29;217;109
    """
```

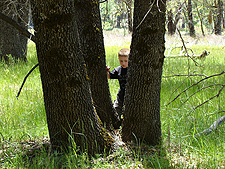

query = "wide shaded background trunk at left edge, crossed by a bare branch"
0;0;28;62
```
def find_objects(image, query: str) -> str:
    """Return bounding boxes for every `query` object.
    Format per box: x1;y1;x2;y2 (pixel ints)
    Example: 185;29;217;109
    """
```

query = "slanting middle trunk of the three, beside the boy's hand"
75;0;120;129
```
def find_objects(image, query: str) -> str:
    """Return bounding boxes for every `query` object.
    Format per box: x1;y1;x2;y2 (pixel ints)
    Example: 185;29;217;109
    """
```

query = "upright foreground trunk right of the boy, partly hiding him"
122;0;166;145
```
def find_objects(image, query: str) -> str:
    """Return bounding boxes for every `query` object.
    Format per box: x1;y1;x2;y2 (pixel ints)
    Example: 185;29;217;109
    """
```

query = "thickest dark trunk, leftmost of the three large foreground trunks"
31;0;113;154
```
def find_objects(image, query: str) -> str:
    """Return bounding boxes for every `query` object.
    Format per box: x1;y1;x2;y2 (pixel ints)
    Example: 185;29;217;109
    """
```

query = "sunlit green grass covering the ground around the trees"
0;33;225;168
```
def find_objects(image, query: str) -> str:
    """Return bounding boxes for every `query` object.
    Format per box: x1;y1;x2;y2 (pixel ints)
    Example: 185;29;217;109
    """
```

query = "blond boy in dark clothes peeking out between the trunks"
106;48;130;119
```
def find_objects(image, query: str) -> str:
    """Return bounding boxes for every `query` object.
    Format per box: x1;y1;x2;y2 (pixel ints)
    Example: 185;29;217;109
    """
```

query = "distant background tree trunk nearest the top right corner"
214;0;223;35
